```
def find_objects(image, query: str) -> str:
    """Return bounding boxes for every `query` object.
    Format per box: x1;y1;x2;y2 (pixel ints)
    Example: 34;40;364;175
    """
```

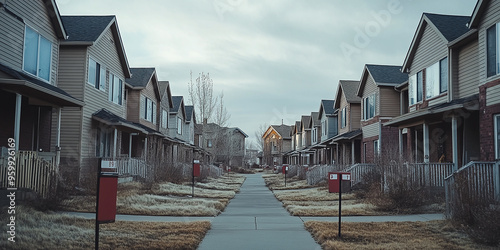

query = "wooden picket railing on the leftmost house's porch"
0;151;57;199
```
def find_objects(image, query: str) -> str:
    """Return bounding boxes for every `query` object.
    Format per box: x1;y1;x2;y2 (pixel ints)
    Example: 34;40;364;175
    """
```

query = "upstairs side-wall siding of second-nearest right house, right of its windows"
458;41;479;98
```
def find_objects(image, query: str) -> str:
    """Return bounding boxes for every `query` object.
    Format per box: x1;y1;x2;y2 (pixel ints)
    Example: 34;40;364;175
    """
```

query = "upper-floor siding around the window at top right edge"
478;1;500;84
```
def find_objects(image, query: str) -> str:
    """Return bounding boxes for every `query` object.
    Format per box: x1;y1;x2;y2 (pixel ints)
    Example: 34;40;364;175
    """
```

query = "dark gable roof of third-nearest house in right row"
357;64;408;97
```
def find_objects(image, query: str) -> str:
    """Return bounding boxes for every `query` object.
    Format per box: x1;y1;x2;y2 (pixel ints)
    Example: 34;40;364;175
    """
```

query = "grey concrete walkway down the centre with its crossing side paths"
64;174;444;250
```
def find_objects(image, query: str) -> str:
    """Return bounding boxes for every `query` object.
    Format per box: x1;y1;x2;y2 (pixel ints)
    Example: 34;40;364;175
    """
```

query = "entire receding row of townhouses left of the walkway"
0;0;211;193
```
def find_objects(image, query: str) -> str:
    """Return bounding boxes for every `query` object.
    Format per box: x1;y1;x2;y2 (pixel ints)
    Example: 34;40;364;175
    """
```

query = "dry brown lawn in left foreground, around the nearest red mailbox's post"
0;206;210;249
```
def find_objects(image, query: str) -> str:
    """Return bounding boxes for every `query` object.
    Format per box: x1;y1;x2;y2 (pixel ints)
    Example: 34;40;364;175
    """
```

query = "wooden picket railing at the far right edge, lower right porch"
445;161;500;218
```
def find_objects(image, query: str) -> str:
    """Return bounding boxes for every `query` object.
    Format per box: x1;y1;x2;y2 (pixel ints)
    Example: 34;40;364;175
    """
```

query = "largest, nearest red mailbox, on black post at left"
97;173;118;223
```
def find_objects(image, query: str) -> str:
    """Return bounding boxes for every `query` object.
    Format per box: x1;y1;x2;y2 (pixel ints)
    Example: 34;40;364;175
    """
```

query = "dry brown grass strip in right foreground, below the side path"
305;221;493;249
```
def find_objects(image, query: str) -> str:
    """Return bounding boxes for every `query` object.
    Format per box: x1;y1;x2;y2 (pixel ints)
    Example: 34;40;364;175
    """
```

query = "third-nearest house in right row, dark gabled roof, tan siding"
357;64;408;163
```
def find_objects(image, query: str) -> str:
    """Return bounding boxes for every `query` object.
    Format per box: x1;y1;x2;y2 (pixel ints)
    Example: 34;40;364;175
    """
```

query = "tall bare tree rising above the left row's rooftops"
188;71;218;122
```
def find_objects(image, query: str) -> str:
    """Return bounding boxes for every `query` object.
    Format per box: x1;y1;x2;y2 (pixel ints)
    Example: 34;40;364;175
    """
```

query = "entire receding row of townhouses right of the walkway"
263;0;500;180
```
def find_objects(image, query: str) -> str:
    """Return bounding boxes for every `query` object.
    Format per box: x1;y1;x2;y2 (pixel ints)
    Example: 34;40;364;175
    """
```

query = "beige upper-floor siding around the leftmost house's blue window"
0;0;59;85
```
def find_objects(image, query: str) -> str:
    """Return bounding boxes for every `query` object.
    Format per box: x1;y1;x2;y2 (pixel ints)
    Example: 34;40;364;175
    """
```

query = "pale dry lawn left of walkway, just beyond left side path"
61;174;245;216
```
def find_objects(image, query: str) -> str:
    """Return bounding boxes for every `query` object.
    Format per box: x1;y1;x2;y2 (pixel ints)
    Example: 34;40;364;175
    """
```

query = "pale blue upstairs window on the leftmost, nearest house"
23;26;52;82
